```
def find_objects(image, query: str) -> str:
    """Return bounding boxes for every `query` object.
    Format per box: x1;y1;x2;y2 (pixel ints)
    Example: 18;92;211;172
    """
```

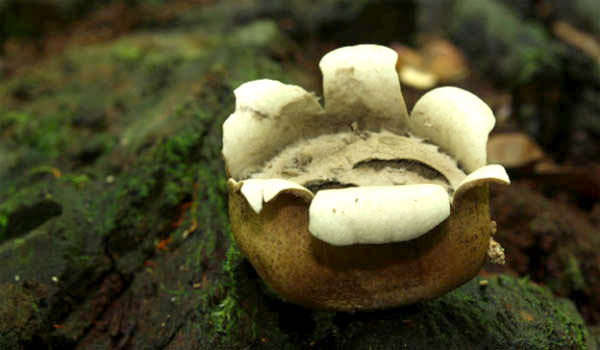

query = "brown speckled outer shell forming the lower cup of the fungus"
229;184;491;311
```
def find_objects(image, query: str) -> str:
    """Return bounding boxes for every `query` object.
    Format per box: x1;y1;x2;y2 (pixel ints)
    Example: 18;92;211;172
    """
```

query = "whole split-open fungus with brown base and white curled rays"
223;45;509;311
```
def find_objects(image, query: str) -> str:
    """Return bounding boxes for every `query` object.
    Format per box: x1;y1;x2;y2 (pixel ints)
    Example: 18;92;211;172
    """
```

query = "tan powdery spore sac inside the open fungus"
250;130;466;194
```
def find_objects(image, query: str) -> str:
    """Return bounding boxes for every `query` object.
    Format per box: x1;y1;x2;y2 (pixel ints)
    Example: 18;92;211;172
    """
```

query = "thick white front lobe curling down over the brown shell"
309;184;450;246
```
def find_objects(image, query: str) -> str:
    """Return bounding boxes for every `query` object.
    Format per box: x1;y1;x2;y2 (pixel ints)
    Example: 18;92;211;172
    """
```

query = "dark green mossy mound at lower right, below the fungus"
332;275;590;349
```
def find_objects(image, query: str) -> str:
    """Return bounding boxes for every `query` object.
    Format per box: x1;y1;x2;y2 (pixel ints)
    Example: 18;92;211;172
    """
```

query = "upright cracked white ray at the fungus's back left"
223;79;323;179
